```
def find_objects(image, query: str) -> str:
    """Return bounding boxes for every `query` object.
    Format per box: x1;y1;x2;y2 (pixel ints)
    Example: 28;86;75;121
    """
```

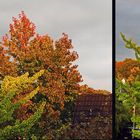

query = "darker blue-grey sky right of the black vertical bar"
116;0;140;61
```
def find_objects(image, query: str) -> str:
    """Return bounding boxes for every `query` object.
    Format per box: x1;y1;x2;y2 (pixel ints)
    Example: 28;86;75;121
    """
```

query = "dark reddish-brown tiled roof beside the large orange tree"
74;94;112;123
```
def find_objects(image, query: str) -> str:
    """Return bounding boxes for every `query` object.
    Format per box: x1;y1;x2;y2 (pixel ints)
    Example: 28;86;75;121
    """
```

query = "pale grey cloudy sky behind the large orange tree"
0;0;112;91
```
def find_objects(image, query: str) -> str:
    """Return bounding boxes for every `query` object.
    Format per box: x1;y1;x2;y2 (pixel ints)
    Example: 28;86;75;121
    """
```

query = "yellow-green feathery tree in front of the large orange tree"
0;70;46;140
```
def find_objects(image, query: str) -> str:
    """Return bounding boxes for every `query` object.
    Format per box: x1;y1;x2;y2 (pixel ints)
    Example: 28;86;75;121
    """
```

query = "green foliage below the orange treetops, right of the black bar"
116;80;140;138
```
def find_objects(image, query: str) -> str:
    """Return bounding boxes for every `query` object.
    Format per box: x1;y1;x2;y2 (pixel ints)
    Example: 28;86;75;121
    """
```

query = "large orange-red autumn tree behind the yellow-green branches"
0;12;82;138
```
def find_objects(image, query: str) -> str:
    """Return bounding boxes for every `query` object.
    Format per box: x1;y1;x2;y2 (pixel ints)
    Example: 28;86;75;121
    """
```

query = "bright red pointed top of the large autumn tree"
9;12;35;47
